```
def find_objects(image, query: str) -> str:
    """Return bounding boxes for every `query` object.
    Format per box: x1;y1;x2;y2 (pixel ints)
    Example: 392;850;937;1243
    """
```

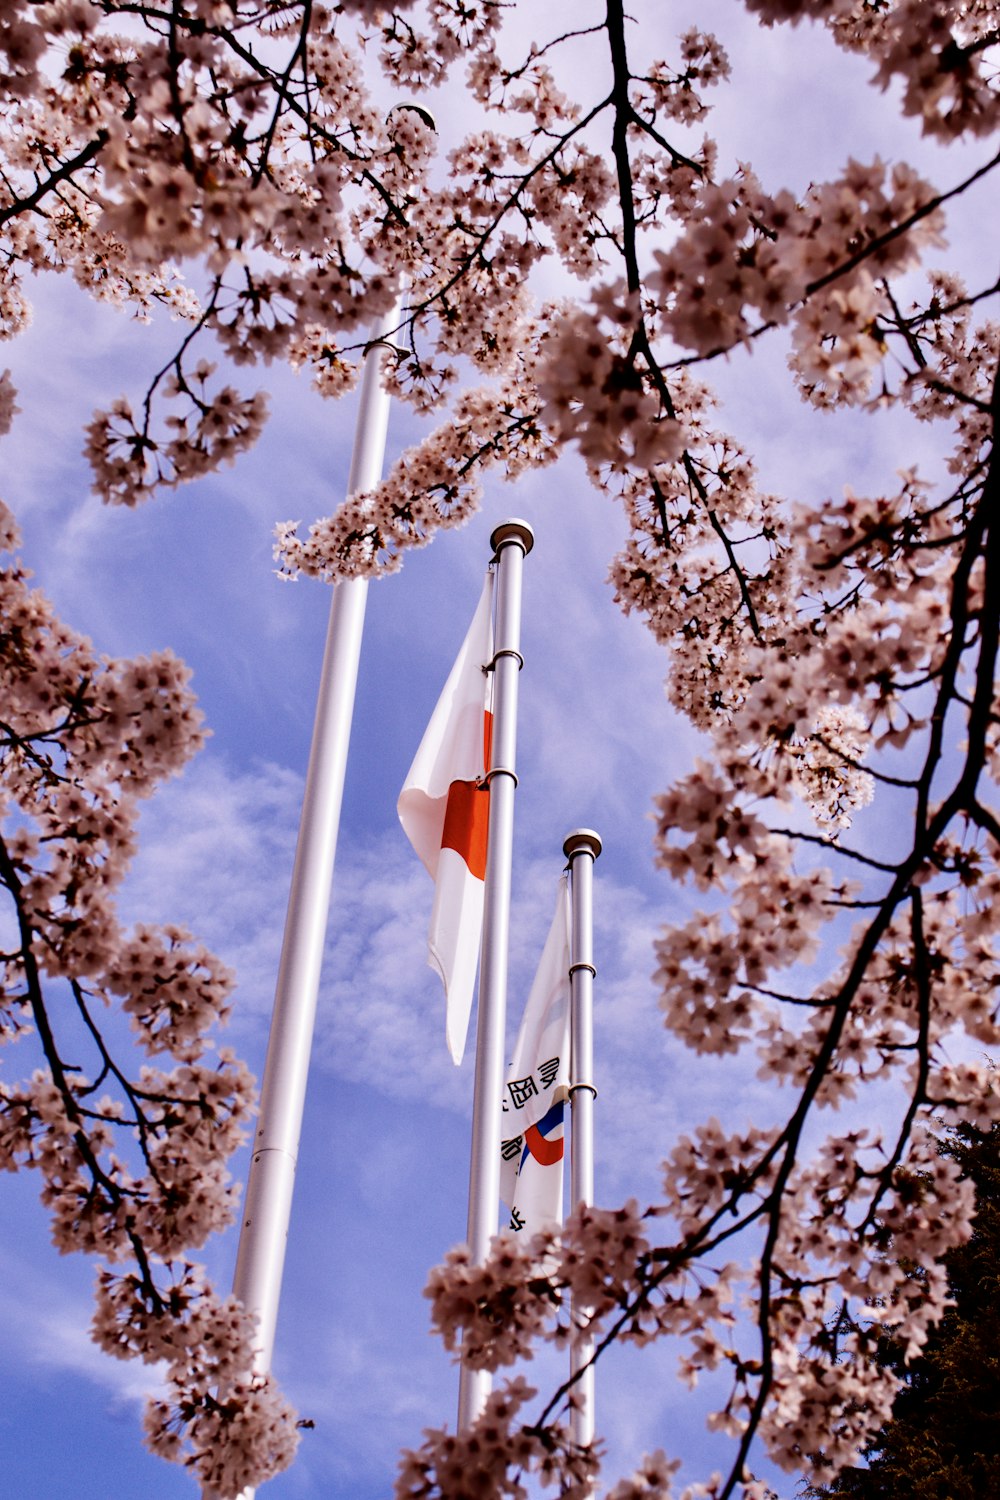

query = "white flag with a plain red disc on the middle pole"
397;573;493;1064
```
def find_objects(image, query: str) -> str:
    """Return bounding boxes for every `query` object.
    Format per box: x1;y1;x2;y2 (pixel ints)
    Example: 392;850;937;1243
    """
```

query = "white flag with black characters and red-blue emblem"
501;876;570;1235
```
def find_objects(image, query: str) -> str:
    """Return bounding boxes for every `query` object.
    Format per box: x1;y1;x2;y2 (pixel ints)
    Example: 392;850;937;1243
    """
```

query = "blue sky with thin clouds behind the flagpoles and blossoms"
0;0;987;1500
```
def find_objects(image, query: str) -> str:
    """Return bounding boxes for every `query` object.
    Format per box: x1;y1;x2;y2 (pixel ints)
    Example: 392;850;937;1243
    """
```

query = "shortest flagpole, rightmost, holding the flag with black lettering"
562;828;601;1448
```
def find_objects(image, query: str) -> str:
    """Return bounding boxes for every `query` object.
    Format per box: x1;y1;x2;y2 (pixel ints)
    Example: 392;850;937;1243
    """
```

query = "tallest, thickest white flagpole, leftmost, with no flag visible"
202;308;400;1500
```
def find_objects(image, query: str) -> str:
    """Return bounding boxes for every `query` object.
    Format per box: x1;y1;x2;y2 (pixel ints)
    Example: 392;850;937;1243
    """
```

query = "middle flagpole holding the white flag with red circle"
459;521;535;1431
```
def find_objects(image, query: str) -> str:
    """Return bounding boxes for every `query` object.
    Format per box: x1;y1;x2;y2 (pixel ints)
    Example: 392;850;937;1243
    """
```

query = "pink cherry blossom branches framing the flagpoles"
0;0;1000;1500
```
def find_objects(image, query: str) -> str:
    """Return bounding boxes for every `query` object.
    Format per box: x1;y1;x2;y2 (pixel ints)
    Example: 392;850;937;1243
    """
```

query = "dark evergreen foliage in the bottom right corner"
802;1125;1000;1500
